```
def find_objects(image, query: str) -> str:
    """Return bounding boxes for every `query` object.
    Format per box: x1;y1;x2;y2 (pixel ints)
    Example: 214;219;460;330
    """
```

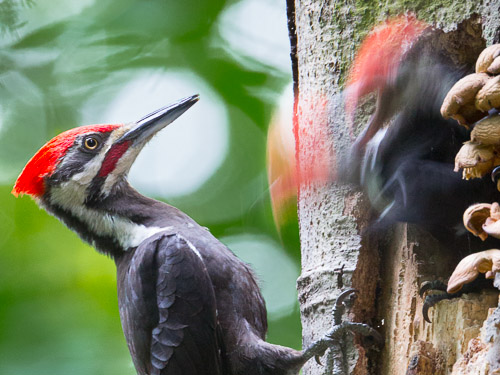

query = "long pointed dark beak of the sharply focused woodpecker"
115;95;200;144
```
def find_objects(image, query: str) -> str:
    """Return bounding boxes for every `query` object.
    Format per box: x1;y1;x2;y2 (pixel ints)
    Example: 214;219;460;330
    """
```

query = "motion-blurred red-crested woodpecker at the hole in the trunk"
339;16;496;239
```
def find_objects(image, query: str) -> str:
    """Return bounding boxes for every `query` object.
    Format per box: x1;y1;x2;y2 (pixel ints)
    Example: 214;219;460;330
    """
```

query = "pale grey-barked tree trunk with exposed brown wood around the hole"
289;0;500;375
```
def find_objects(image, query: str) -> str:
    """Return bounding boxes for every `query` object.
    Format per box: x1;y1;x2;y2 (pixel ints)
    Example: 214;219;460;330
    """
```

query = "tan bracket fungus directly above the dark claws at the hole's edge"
447;249;500;293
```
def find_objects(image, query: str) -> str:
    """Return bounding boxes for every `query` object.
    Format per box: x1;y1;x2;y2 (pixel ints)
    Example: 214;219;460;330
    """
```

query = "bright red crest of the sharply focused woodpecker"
12;124;121;198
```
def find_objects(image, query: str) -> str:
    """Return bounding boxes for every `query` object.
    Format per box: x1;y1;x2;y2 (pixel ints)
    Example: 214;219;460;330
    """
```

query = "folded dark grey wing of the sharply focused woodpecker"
127;234;222;375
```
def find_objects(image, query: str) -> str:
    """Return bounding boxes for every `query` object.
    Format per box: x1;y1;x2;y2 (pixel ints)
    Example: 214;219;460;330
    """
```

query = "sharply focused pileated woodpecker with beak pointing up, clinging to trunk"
13;95;376;375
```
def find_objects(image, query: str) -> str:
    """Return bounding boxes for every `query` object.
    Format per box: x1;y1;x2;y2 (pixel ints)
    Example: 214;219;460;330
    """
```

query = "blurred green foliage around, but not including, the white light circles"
0;0;300;375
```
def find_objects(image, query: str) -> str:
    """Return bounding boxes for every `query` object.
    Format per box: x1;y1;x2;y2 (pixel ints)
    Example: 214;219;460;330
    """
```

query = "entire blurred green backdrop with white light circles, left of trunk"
0;0;300;375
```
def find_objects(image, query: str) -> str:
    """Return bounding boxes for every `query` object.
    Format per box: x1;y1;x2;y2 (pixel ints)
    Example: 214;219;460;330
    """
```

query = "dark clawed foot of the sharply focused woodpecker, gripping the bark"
304;289;383;375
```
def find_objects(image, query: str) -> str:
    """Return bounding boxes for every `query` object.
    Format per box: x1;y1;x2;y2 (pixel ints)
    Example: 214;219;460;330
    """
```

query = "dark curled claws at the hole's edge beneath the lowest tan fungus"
419;279;491;323
